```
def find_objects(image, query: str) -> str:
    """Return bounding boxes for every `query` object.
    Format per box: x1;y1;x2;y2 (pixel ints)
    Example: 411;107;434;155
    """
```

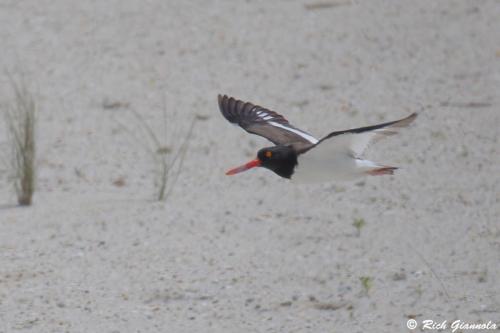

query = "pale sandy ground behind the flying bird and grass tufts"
0;0;500;333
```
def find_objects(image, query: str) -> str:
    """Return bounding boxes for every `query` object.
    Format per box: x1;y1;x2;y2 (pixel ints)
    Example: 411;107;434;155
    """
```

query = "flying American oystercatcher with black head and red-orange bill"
219;95;417;182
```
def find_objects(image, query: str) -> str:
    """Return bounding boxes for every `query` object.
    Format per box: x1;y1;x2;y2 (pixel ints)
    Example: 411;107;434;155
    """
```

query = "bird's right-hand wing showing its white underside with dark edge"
314;113;417;156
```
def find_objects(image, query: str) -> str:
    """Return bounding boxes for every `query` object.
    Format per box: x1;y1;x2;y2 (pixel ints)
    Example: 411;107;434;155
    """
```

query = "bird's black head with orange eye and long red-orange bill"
226;146;297;178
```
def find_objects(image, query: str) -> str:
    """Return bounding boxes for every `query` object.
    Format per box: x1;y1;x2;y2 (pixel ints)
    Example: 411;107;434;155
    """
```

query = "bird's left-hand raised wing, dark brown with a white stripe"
219;95;318;145
